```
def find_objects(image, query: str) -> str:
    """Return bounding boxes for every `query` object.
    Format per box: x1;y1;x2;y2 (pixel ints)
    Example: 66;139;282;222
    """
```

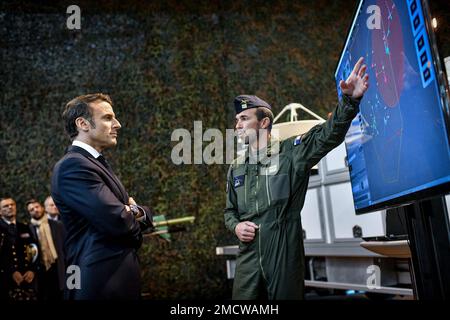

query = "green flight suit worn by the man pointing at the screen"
225;96;359;300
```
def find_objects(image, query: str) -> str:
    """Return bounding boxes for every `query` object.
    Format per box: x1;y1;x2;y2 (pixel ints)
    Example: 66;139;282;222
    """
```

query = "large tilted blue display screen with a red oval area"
335;0;450;213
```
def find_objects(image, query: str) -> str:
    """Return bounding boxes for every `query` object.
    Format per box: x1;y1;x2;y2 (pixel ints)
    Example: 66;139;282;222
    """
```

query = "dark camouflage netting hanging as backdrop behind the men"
0;0;450;299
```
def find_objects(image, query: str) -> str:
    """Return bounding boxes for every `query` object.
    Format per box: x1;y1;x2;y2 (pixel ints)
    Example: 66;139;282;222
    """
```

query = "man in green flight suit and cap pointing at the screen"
225;58;369;300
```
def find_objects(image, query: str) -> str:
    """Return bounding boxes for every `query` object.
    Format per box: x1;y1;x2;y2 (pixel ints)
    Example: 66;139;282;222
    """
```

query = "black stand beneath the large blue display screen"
387;197;450;300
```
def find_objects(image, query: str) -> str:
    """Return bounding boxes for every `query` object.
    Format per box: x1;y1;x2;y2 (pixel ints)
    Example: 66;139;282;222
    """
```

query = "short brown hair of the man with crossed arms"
63;93;112;139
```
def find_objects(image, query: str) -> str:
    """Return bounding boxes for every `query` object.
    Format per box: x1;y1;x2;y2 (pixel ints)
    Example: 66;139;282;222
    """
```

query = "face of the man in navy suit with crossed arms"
87;101;121;152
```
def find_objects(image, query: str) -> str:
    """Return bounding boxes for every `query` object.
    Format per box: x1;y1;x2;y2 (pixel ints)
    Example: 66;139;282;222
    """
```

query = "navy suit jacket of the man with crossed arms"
51;146;142;300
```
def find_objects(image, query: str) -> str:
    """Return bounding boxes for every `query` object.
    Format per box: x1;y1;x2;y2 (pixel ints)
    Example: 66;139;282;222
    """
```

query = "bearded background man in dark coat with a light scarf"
26;199;66;300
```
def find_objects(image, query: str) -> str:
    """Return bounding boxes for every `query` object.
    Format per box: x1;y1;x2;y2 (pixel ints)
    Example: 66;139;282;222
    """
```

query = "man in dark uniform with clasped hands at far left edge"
0;197;38;300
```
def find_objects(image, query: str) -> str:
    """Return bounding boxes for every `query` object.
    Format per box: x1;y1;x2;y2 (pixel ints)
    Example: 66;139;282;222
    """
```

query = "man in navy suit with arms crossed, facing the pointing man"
51;93;152;300
